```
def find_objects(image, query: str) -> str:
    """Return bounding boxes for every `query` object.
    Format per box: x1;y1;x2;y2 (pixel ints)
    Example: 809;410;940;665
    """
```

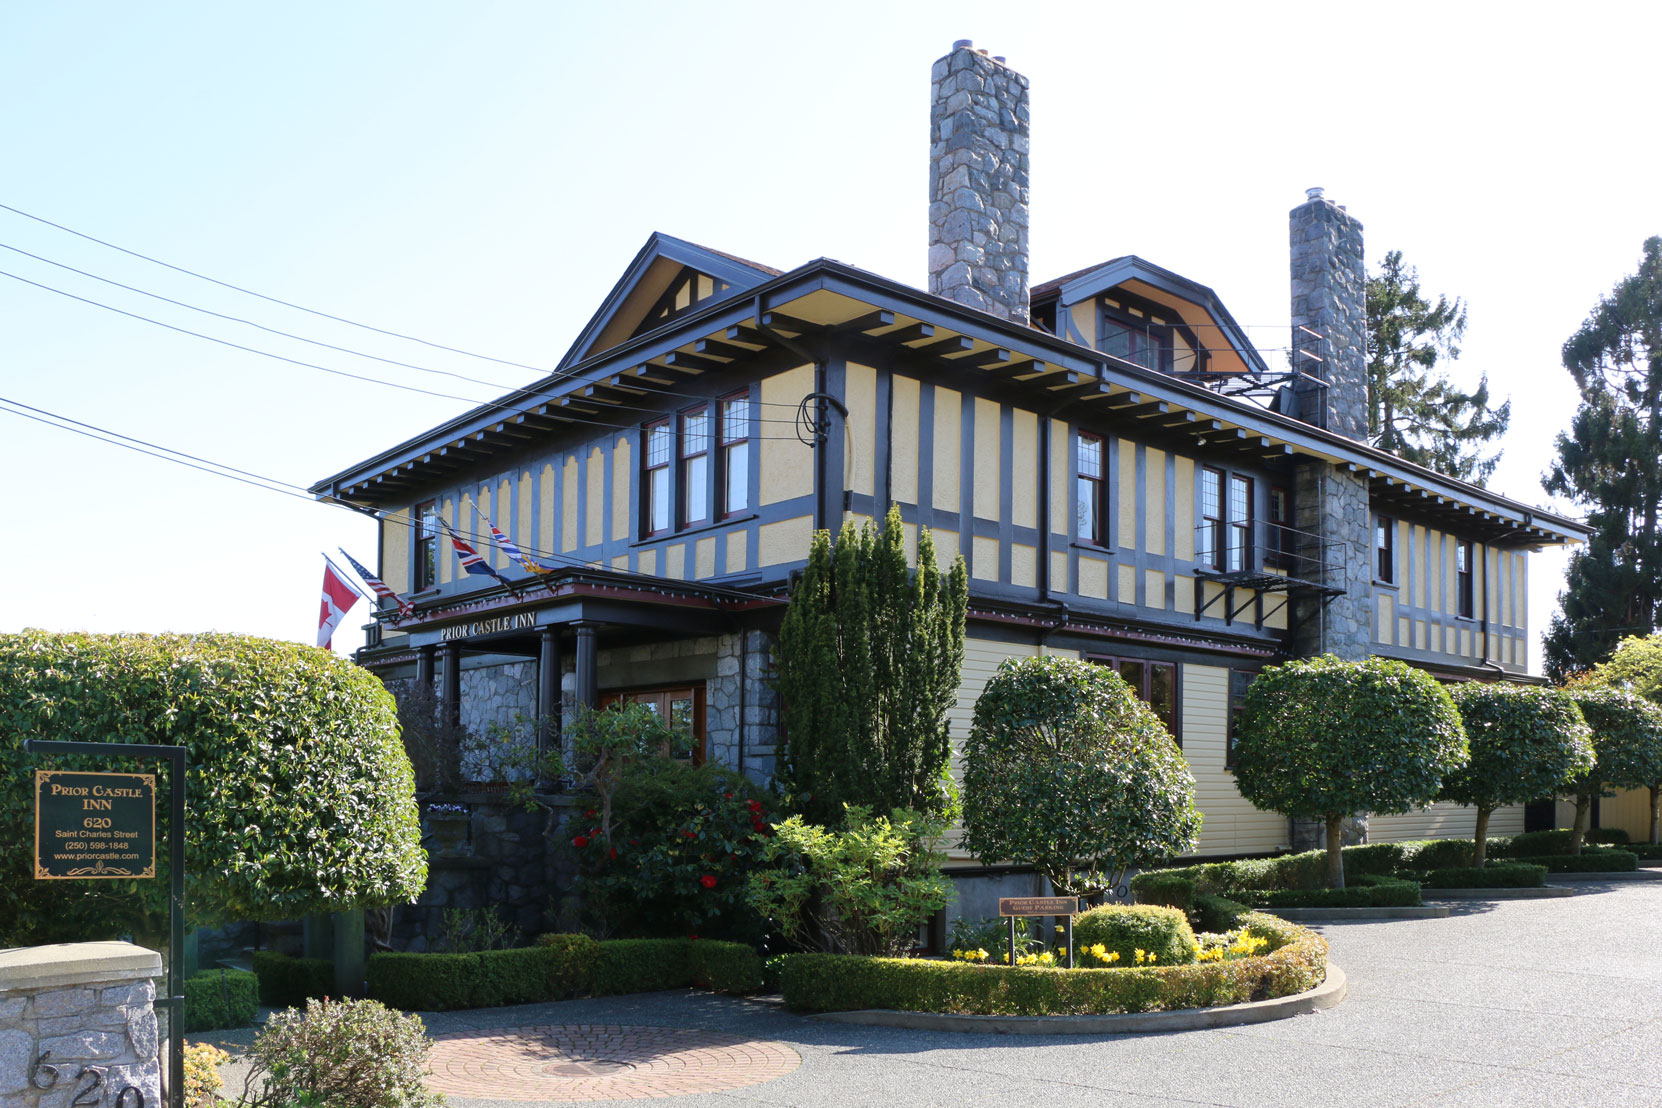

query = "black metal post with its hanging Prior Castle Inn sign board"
23;739;186;1108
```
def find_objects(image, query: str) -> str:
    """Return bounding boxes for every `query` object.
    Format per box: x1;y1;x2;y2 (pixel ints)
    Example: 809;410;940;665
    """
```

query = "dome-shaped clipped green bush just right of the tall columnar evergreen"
962;658;1200;900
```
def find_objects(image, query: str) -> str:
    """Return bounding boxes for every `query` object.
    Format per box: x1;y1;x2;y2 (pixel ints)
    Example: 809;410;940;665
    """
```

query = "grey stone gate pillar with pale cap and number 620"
0;942;161;1108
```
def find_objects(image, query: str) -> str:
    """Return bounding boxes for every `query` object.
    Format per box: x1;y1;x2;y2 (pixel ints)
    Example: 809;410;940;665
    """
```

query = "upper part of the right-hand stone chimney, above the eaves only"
1286;188;1368;442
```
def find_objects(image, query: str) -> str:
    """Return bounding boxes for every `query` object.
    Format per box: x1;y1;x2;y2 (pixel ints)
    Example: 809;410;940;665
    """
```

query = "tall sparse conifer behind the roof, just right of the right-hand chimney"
1368;251;1512;485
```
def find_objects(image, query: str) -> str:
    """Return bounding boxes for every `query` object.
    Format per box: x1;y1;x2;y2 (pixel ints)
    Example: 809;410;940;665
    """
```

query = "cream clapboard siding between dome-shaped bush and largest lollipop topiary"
1178;664;1286;854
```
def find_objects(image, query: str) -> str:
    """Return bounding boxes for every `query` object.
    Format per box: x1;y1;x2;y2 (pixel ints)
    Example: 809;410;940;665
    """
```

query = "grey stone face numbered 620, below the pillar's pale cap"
0;960;161;1108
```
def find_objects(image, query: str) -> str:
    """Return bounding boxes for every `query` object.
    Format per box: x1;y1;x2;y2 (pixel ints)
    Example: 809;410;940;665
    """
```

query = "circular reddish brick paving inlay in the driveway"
427;1023;803;1100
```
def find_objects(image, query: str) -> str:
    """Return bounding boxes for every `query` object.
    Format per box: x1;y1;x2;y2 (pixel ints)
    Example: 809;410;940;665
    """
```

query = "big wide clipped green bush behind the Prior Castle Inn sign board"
0;631;427;945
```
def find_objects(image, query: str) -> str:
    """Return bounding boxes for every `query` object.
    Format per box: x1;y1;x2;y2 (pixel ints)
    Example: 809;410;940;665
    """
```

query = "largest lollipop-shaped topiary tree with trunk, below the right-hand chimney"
1235;655;1466;889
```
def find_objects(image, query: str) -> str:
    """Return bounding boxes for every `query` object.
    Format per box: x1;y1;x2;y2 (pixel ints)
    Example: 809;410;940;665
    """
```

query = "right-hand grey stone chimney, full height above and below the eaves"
1288;188;1374;659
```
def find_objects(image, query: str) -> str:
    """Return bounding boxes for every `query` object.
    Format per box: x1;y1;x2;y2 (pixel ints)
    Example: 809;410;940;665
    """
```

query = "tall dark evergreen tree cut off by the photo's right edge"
1544;238;1662;679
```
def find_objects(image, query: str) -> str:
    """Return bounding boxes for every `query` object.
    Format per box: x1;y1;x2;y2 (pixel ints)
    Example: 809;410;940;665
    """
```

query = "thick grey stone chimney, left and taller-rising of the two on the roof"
929;38;1029;322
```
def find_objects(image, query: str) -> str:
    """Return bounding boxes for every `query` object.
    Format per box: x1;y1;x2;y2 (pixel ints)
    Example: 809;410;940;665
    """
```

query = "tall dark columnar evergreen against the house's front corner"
774;508;969;826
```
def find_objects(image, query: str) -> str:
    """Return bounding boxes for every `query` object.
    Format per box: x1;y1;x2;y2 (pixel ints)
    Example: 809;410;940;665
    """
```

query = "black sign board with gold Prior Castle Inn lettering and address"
35;769;156;880
